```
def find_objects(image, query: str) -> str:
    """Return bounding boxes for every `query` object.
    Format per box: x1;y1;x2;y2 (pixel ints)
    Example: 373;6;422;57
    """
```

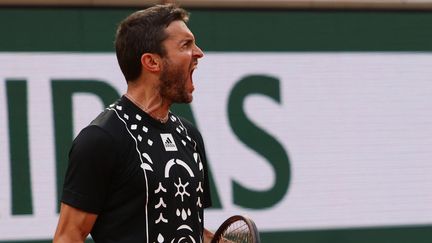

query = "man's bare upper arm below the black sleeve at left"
53;203;97;243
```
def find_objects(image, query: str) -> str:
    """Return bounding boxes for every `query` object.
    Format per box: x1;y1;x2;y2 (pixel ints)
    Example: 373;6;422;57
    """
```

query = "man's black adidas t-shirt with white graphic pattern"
62;96;211;243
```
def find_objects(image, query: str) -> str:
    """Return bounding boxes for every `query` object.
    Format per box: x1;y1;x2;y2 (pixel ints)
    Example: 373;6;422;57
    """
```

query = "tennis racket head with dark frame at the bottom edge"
211;215;260;243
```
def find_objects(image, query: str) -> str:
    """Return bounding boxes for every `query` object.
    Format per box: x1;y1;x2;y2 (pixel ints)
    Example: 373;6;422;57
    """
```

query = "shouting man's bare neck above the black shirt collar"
125;89;170;123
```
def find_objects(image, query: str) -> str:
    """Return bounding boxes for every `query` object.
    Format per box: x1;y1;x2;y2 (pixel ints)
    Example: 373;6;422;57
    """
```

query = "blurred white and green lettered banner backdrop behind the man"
0;0;432;243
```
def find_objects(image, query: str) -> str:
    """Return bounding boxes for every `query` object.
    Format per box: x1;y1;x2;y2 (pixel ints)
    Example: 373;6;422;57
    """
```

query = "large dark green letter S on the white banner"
228;75;291;209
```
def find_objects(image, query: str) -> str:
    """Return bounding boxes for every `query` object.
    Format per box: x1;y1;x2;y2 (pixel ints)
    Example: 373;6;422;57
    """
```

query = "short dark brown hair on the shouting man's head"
115;4;189;82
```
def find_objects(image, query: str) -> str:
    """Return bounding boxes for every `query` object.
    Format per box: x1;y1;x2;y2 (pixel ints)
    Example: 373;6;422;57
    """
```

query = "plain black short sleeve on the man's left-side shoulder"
61;126;116;214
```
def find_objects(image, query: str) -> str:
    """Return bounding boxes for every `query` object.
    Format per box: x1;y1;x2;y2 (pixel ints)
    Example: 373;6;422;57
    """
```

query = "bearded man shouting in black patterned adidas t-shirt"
54;5;212;243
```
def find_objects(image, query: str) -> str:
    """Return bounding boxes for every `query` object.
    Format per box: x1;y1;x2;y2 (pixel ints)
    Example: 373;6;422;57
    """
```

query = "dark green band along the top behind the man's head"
0;8;432;52
